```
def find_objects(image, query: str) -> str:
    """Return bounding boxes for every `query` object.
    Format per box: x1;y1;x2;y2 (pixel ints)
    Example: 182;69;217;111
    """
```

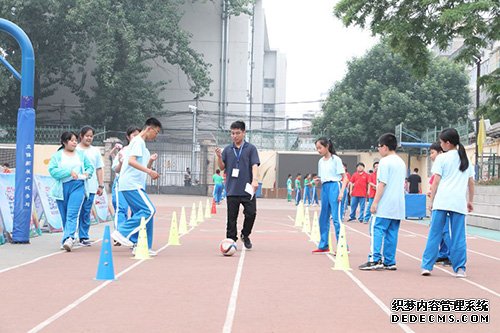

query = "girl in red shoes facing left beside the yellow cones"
312;137;347;253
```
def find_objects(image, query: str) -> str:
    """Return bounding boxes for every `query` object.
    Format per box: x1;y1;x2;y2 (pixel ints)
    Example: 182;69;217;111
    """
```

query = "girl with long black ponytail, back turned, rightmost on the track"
422;128;474;278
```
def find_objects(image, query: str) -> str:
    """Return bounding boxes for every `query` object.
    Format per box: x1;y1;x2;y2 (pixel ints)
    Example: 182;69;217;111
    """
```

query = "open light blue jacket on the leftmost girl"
49;149;94;200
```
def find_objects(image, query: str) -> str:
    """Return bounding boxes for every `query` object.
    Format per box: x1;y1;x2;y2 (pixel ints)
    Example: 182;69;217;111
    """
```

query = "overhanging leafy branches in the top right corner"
334;0;500;111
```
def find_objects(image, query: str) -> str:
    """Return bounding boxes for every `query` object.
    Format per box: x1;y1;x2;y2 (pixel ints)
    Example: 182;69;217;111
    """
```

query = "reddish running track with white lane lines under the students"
0;195;500;333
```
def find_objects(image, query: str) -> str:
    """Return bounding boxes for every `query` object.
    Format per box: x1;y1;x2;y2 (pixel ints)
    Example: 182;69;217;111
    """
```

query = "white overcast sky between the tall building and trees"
262;0;376;117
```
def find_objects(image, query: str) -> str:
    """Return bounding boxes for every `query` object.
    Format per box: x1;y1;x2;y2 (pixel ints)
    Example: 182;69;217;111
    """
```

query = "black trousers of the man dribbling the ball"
226;196;257;241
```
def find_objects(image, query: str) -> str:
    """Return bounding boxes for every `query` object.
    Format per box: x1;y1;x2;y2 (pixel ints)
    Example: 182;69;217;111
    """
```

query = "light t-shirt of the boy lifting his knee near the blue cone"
118;135;151;191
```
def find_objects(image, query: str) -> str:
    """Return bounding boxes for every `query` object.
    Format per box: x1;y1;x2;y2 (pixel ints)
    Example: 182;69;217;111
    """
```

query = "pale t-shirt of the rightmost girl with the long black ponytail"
431;150;475;215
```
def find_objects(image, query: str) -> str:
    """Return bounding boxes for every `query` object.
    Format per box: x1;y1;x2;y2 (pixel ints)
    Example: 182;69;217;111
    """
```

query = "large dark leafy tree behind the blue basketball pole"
0;0;211;130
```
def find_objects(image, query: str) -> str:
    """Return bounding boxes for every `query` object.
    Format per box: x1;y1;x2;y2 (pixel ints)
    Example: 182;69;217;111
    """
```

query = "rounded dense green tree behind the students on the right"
313;43;469;149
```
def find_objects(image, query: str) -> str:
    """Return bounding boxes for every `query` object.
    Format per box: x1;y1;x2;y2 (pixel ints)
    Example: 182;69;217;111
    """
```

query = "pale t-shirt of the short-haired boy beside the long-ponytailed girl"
376;155;406;220
